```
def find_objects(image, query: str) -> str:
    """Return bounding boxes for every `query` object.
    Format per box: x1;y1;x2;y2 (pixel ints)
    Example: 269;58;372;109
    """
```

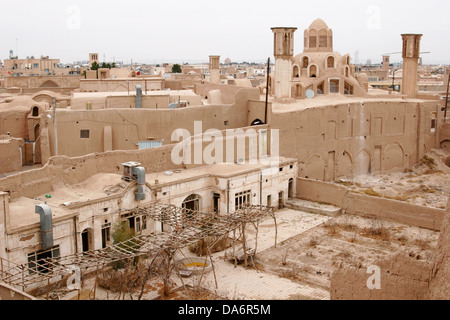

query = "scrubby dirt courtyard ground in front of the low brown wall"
258;211;439;290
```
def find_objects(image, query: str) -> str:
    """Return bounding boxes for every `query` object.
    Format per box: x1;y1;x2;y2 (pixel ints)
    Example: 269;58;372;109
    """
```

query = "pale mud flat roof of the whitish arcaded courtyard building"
9;157;297;231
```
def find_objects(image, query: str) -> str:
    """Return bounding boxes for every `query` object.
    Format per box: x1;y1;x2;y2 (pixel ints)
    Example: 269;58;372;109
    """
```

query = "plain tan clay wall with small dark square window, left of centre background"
41;90;264;156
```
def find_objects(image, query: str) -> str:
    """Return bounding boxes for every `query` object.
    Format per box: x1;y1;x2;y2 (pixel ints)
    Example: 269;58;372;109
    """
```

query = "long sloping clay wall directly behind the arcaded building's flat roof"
0;125;270;199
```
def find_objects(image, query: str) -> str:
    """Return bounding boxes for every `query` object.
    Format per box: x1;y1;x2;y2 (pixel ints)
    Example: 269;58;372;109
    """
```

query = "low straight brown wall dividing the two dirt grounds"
296;178;445;231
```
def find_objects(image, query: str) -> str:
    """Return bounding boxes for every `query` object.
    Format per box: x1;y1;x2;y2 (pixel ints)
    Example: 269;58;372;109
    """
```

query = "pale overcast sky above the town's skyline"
0;0;450;64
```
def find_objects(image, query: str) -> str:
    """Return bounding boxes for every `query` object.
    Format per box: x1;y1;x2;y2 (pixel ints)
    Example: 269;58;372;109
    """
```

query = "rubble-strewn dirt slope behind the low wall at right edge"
336;149;450;209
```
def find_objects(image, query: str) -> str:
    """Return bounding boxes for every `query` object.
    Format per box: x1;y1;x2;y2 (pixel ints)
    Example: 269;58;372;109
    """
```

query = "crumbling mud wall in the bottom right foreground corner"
330;195;450;300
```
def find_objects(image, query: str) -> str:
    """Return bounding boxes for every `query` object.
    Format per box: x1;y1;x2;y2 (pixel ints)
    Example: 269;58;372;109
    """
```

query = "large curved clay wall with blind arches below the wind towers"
271;100;441;181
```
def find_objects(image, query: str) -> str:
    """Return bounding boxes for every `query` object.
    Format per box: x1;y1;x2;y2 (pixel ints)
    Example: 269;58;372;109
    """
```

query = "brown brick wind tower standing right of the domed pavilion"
402;34;422;98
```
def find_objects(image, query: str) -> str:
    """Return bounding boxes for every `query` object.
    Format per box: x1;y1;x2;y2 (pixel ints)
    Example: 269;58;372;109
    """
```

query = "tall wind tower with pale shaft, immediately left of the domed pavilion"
271;27;297;98
